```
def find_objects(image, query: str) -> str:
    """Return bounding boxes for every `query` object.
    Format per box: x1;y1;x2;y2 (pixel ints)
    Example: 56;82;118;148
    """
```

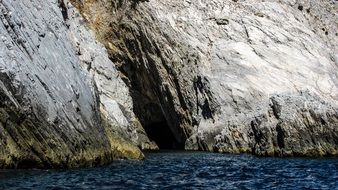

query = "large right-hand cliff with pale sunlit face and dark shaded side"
72;0;338;156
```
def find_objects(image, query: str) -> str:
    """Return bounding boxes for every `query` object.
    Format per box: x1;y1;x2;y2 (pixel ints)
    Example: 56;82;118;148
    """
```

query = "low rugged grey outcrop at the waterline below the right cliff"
210;92;338;156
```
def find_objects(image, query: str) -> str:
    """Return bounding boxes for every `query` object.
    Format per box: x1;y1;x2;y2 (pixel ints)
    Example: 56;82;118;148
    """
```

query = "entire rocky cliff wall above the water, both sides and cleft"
0;0;338;168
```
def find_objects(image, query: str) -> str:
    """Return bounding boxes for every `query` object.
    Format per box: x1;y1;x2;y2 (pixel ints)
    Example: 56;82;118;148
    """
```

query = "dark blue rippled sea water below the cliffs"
0;152;338;189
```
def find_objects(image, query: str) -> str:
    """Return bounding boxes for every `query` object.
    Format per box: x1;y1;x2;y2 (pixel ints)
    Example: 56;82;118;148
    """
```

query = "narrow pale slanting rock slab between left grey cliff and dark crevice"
67;3;158;149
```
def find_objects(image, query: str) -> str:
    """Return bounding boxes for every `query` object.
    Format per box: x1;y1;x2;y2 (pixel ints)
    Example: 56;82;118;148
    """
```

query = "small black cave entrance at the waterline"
144;121;184;150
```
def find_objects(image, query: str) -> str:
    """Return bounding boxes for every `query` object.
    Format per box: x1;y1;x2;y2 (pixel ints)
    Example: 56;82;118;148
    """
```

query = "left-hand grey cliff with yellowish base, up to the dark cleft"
0;0;146;168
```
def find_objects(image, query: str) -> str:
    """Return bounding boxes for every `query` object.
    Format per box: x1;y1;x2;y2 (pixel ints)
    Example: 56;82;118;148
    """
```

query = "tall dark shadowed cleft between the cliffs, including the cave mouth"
110;25;186;150
